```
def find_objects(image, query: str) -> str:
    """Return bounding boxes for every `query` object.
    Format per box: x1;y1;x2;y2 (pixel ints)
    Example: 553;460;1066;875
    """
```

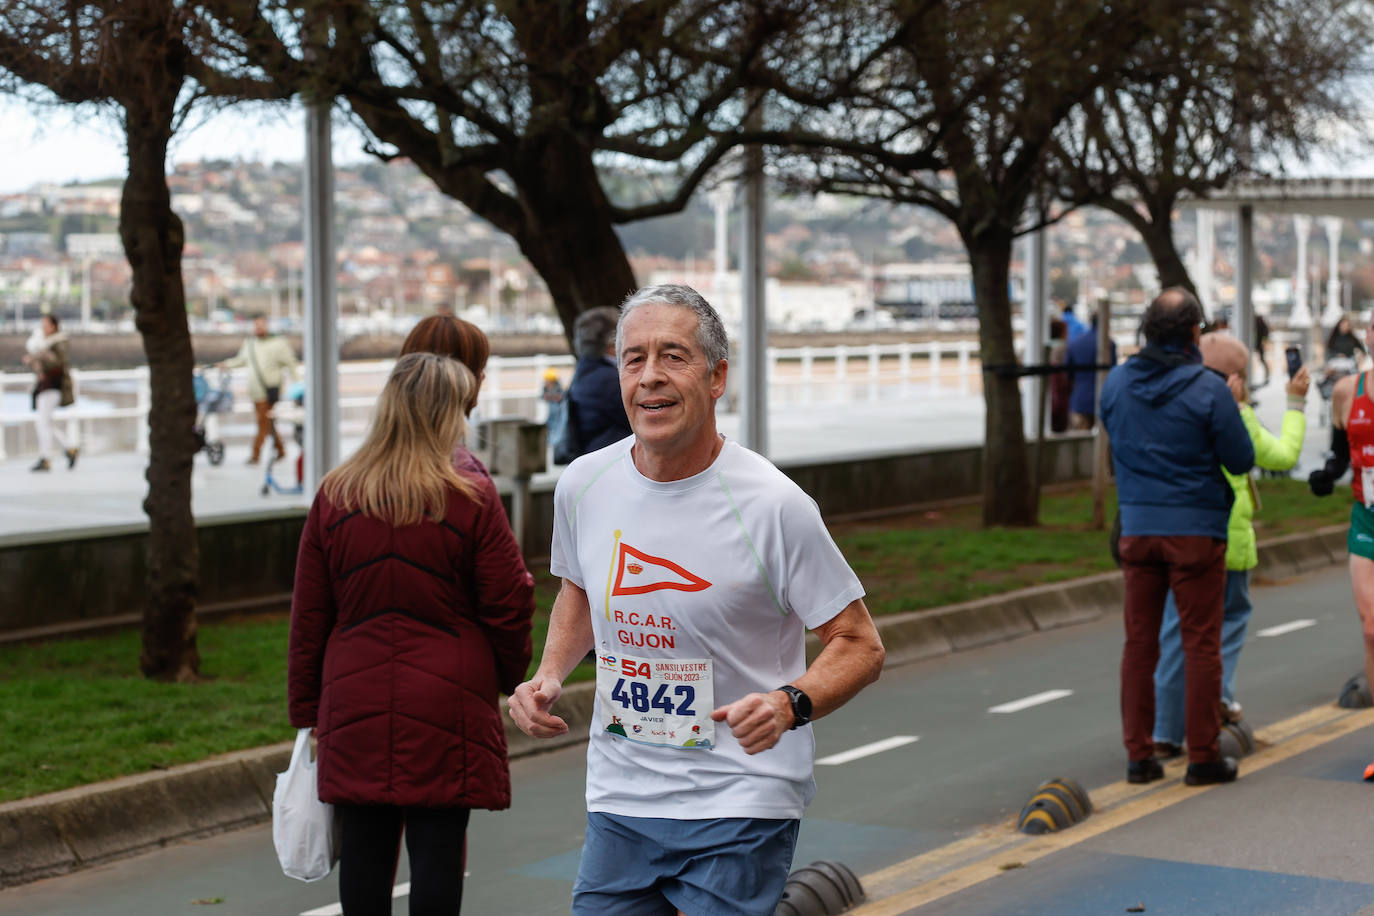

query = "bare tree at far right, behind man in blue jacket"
1052;0;1370;305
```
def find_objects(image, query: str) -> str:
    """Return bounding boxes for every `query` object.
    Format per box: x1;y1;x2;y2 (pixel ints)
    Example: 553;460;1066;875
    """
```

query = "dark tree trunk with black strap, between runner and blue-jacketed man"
965;227;1039;527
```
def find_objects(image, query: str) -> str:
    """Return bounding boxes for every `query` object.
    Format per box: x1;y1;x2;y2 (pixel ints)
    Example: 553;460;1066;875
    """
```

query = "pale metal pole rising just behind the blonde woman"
304;102;339;496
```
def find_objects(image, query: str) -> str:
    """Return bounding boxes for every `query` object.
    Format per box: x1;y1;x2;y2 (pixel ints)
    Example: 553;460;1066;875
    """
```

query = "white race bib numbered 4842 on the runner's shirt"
596;652;716;750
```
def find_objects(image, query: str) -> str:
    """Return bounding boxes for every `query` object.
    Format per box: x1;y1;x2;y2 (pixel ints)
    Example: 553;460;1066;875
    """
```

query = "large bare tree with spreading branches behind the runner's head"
206;0;802;343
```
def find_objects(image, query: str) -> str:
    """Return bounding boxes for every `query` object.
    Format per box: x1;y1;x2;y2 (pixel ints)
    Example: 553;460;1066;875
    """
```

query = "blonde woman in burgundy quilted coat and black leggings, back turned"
287;353;534;916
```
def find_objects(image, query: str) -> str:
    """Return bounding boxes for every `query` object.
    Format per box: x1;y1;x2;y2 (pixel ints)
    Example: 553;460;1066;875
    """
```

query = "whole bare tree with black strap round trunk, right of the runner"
764;0;1180;525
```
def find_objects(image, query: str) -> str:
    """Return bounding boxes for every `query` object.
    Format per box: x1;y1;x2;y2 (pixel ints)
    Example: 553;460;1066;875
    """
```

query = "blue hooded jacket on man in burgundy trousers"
1102;345;1254;541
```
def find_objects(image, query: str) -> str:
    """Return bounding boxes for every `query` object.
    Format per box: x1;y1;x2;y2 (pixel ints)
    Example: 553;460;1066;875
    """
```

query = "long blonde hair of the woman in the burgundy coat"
320;353;477;527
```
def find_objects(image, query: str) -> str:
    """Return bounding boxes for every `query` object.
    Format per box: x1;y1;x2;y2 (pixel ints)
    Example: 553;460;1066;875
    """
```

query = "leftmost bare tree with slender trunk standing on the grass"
0;0;281;681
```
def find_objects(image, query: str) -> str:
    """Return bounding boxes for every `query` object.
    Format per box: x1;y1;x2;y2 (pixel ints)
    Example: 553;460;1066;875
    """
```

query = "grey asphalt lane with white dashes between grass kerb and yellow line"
0;567;1360;916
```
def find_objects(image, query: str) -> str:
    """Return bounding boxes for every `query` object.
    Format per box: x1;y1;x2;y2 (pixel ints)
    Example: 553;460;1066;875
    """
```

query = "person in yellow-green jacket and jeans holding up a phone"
1154;332;1309;759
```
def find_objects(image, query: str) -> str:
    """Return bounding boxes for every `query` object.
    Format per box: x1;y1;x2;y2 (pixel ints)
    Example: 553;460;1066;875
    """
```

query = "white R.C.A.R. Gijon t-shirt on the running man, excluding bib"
550;437;864;820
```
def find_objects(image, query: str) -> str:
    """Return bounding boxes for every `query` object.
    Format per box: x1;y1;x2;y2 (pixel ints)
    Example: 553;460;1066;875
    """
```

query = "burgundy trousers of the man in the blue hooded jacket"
1121;536;1226;764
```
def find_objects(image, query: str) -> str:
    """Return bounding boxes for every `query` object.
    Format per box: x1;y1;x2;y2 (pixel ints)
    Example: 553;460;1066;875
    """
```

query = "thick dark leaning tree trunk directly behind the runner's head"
515;136;638;346
